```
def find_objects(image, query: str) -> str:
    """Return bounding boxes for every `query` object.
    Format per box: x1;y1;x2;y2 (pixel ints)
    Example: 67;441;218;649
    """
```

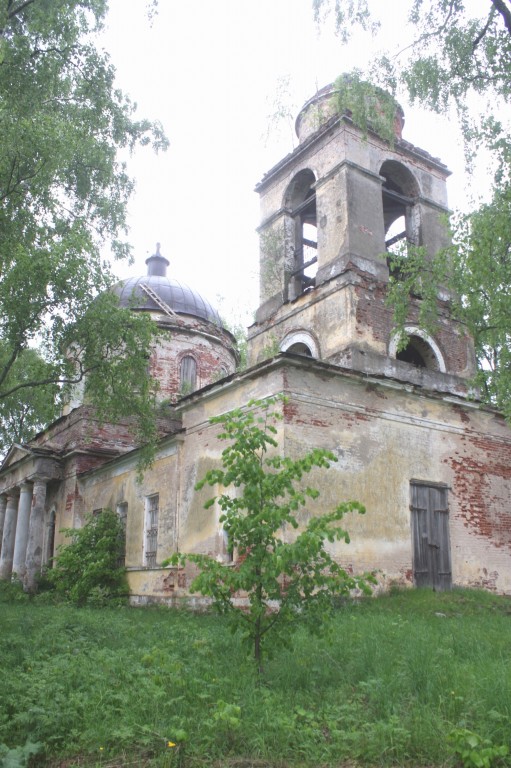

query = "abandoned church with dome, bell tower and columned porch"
0;86;511;604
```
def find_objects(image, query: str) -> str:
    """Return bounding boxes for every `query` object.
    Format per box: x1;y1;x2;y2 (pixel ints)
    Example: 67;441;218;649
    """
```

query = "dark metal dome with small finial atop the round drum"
112;243;223;328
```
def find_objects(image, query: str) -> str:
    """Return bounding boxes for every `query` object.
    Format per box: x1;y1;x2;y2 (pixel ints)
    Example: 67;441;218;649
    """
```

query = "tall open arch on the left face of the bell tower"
284;169;318;298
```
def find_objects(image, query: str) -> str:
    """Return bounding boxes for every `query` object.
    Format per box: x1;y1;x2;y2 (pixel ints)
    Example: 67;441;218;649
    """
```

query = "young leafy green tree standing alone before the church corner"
166;398;372;668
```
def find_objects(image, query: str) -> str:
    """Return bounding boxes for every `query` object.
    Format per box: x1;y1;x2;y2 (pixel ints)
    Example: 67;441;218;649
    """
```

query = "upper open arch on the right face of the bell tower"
380;160;420;268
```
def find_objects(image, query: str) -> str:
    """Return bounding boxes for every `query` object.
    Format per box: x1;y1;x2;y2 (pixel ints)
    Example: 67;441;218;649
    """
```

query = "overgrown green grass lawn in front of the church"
0;590;511;768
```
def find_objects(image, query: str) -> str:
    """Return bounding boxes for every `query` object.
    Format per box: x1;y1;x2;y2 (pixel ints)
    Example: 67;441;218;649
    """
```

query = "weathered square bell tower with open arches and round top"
249;85;475;392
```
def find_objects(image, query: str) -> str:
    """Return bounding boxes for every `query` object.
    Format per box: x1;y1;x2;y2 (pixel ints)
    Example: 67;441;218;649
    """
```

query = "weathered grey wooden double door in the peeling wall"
410;481;452;592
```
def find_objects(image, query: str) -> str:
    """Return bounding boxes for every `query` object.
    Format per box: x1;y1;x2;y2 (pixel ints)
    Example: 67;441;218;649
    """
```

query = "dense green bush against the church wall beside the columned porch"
47;510;128;605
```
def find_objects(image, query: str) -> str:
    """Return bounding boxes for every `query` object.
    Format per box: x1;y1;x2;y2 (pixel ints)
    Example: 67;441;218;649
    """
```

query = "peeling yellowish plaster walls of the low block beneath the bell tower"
99;359;511;602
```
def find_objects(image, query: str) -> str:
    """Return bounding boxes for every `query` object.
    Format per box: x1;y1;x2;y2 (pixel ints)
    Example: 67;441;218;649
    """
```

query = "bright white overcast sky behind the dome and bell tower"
104;0;482;324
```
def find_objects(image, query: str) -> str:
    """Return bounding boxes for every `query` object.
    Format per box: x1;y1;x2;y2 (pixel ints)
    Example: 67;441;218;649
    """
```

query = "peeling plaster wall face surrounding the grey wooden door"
280;369;511;593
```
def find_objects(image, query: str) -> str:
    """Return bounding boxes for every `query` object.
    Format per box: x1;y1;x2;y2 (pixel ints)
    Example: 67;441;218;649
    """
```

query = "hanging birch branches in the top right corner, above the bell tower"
313;0;511;123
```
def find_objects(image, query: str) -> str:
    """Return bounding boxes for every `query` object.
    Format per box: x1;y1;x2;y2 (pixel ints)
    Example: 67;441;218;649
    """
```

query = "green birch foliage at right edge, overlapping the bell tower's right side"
388;185;511;420
